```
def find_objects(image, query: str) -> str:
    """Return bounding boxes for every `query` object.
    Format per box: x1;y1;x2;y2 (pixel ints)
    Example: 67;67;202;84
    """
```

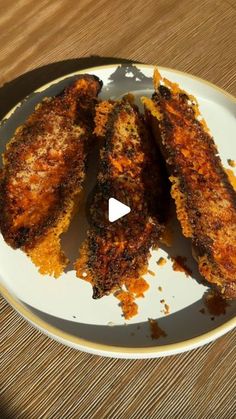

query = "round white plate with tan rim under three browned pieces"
0;64;236;358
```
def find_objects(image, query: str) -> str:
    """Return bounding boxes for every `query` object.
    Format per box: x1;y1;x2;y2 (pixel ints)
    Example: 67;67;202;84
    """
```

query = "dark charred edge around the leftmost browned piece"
0;74;103;251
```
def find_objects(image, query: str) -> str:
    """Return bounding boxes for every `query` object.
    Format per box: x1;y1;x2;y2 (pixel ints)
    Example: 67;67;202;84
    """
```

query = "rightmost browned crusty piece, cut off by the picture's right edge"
143;70;236;298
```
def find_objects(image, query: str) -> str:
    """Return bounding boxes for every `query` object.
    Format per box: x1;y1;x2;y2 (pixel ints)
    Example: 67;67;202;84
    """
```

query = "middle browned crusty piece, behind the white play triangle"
75;100;166;298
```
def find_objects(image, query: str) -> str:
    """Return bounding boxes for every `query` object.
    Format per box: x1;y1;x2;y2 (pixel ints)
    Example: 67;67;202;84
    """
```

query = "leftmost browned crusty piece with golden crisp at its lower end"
0;75;101;277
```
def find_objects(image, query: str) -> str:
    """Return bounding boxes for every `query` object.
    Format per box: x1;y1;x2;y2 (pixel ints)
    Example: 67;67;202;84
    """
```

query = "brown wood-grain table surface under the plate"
0;0;236;419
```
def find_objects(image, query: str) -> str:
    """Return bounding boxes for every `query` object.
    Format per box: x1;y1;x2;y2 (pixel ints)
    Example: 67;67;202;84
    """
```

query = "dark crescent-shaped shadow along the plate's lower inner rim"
23;300;235;348
